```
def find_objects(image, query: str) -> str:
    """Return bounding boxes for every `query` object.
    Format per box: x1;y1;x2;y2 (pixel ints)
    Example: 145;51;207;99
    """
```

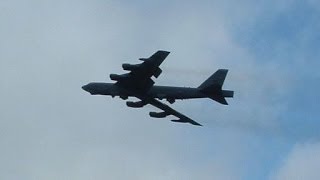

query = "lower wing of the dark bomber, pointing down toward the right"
148;99;202;126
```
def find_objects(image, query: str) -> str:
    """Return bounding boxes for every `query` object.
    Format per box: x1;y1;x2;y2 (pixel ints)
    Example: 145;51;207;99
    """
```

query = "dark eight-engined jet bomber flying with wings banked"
82;50;233;126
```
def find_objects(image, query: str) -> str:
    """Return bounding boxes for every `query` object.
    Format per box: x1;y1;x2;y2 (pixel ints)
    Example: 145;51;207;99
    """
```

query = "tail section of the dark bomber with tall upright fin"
198;69;234;105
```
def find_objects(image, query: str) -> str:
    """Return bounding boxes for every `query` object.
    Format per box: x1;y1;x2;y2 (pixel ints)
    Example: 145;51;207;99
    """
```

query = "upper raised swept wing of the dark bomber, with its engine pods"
110;51;170;93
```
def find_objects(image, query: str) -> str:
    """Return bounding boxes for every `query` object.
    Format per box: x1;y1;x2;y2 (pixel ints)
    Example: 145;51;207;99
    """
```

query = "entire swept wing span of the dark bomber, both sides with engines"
114;51;202;126
